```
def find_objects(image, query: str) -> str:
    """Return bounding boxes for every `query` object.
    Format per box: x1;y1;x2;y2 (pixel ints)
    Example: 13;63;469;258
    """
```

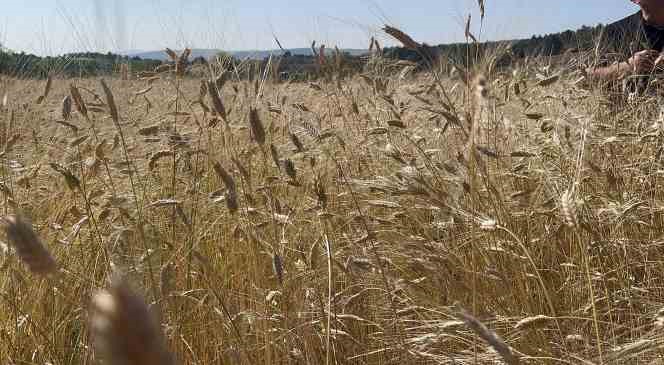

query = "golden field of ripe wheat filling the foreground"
0;20;664;364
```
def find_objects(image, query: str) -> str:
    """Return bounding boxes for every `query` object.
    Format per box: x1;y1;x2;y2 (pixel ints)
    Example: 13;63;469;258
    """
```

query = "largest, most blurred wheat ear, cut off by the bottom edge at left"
90;277;175;365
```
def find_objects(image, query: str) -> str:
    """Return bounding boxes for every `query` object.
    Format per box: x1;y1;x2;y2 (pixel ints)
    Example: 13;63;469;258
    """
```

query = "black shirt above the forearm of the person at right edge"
601;11;664;61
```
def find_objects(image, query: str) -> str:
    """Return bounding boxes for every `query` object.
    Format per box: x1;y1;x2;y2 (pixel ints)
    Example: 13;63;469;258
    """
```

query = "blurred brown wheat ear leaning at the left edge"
3;215;57;275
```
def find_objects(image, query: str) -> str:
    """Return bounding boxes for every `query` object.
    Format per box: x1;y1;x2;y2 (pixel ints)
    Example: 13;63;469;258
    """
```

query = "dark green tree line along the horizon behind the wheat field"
0;24;604;78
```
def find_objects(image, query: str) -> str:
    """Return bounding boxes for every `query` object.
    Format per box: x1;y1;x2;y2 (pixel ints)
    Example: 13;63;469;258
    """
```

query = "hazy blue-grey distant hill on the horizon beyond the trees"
120;48;367;61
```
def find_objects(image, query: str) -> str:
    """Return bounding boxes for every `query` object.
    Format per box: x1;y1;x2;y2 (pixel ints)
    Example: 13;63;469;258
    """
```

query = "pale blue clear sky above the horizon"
0;0;638;55
